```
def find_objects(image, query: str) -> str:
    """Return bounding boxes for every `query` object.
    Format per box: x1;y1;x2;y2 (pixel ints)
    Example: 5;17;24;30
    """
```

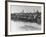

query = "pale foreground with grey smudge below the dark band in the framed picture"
10;21;41;32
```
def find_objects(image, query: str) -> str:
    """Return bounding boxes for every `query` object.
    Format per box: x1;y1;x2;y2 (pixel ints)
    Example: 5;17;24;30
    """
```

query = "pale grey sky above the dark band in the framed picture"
10;5;41;13
